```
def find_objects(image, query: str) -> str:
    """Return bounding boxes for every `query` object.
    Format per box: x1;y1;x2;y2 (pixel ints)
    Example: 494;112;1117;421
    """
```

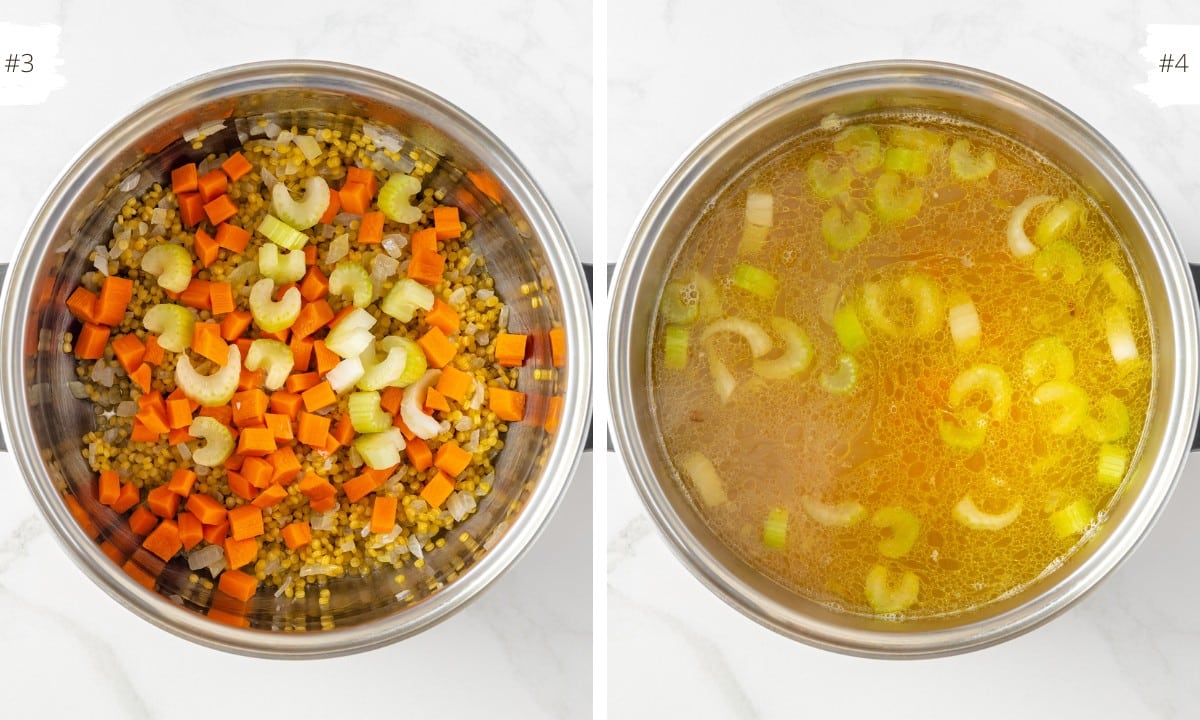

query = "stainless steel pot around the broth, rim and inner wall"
608;61;1198;658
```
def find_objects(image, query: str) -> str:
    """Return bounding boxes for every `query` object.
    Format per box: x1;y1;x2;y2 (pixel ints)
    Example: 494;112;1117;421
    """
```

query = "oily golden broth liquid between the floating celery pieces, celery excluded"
650;116;1152;617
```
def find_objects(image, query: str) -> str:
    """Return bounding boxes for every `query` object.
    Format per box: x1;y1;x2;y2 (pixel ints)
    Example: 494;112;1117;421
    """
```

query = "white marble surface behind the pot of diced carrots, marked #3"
0;0;592;720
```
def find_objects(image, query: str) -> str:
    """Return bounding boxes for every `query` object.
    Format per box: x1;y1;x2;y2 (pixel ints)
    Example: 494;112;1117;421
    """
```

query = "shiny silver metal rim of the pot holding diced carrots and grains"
0;59;592;659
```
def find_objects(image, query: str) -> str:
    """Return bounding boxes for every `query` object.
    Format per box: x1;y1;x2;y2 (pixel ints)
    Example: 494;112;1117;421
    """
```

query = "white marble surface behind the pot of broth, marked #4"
606;0;1200;719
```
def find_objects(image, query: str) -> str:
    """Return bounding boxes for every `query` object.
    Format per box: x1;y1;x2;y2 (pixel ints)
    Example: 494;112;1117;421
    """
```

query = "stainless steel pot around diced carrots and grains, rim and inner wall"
0;61;590;658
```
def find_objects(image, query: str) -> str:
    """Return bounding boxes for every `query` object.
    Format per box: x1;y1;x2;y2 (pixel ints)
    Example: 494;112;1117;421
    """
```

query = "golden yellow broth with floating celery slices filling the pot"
650;116;1153;619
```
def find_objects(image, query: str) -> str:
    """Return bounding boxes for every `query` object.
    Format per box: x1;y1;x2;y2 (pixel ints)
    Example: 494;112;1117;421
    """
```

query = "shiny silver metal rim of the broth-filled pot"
608;60;1200;658
